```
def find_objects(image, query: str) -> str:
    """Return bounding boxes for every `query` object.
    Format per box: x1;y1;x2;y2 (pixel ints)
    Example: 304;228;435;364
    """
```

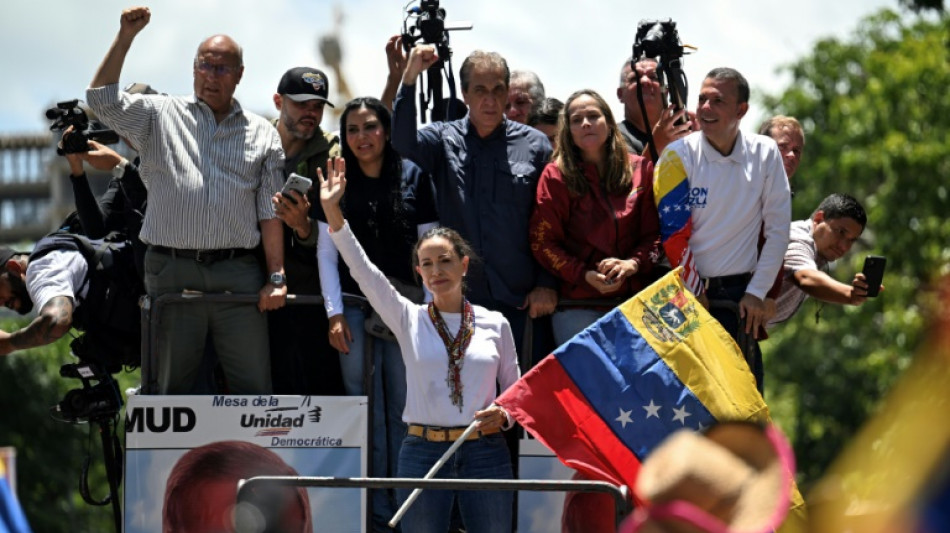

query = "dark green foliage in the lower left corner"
0;319;139;533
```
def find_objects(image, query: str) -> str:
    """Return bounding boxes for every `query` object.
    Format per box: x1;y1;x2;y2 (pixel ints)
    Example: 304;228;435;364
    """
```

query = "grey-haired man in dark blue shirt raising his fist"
392;45;557;362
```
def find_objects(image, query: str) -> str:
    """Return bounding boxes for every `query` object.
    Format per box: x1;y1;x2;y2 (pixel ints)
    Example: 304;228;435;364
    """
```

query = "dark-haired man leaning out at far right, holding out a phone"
766;194;883;328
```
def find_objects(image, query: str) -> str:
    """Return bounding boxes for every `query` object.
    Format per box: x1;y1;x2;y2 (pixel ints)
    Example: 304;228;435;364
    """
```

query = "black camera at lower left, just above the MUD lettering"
50;363;122;422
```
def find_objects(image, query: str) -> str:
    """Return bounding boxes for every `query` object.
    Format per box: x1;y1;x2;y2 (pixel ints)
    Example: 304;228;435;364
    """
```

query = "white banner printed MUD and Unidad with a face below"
125;395;367;533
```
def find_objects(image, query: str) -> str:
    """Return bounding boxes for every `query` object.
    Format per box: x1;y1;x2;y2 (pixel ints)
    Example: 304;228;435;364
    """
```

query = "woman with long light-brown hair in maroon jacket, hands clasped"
530;89;660;344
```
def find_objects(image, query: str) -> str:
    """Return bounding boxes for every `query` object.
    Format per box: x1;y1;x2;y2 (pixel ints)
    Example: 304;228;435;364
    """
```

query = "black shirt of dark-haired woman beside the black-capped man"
317;159;438;294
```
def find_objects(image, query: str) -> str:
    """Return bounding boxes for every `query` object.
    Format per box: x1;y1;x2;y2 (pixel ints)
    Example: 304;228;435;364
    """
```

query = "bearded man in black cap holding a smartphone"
268;67;343;395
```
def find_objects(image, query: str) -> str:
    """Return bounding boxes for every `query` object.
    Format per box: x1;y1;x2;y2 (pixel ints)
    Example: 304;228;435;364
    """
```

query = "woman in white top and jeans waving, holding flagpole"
318;155;520;533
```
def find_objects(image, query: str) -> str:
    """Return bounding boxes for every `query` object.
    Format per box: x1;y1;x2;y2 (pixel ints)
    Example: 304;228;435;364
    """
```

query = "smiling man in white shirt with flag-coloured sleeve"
654;68;791;390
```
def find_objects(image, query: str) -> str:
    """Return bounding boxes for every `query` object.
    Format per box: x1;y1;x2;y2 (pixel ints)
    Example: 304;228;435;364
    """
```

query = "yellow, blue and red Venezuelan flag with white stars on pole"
496;268;801;528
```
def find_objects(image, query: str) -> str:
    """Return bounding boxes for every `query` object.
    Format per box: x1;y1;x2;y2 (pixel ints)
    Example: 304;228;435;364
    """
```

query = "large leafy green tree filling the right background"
764;10;950;485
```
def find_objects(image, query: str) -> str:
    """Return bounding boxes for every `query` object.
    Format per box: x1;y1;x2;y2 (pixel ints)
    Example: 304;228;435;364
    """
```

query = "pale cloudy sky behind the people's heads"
0;0;897;134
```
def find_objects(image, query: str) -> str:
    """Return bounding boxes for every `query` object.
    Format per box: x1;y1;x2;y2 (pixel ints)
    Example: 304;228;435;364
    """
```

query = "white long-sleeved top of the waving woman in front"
330;220;521;427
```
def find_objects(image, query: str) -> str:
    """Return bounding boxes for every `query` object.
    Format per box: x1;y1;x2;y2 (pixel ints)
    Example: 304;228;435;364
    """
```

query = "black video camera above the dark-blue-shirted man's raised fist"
402;0;472;123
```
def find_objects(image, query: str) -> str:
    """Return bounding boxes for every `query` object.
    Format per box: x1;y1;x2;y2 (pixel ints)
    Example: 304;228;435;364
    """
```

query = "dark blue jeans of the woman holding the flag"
396;433;513;533
